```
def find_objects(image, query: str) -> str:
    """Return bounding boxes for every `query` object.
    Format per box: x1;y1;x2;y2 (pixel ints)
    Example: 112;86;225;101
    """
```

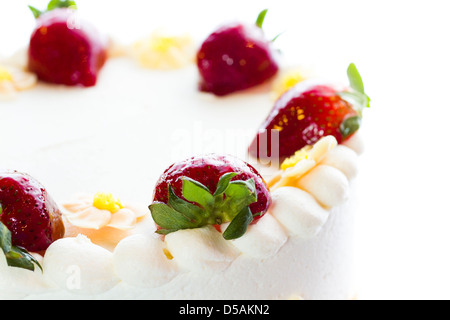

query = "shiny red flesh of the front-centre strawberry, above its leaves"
153;155;271;221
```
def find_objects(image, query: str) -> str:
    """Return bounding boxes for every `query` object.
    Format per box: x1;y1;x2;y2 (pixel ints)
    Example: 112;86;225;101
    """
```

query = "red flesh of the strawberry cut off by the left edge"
0;172;64;252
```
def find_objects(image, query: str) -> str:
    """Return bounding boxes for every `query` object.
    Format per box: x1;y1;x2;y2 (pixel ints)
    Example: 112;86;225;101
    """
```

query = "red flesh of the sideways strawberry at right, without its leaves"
249;85;357;160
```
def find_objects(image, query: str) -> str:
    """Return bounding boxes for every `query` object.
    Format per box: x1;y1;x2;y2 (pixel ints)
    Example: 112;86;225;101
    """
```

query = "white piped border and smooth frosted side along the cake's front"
0;131;356;299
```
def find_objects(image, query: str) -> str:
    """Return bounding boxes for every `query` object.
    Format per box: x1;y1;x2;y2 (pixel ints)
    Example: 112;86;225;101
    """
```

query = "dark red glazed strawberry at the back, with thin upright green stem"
197;10;278;96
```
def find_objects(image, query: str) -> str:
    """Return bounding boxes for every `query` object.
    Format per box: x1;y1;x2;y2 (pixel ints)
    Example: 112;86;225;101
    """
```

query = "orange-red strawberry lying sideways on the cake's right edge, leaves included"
249;64;370;161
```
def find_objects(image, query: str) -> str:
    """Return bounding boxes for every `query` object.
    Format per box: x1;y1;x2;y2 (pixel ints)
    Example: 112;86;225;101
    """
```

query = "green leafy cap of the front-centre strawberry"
149;172;257;239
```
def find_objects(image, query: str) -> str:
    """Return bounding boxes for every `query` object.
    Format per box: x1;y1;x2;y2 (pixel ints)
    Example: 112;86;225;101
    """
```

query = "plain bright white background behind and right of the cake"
0;0;450;299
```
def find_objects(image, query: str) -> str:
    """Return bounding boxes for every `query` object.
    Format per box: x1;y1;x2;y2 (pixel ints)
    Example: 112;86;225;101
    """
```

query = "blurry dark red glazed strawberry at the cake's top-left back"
28;0;107;87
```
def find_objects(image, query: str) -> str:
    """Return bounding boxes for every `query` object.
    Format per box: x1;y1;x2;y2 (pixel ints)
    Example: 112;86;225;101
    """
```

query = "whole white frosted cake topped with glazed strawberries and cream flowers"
0;1;369;300
